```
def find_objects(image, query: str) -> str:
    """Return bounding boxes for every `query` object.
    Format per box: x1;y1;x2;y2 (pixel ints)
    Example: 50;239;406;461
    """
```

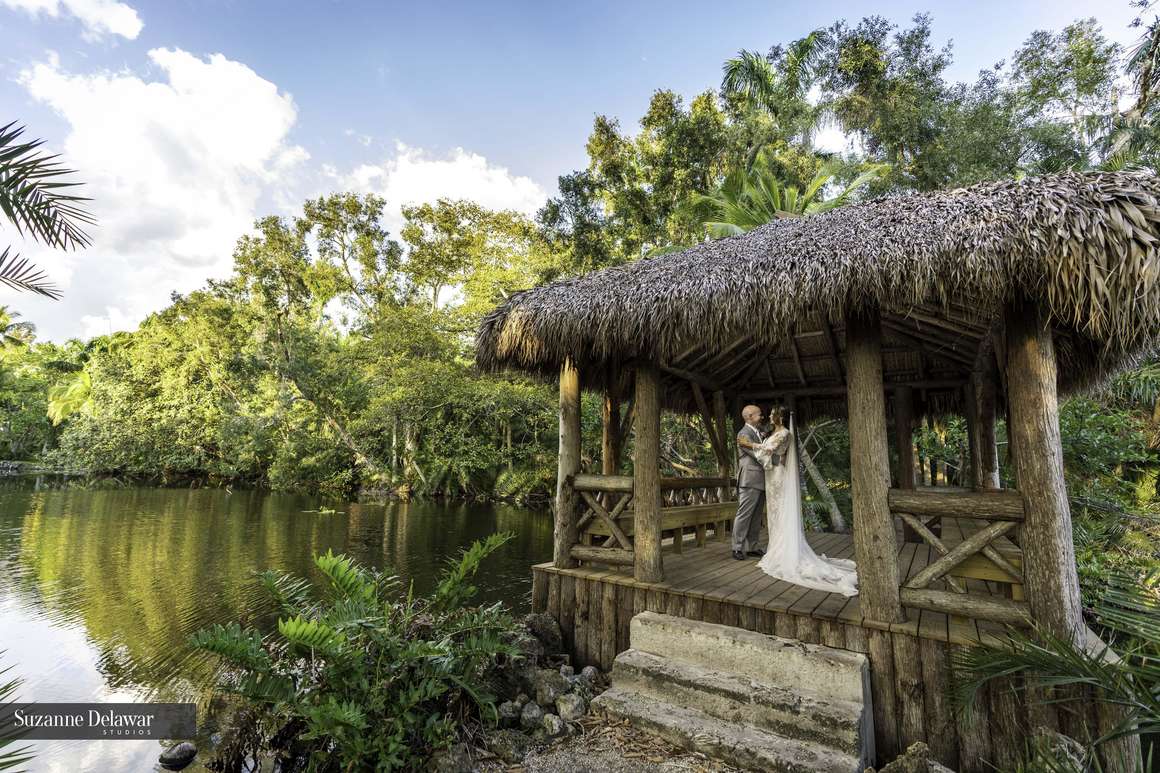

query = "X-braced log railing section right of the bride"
889;489;1030;624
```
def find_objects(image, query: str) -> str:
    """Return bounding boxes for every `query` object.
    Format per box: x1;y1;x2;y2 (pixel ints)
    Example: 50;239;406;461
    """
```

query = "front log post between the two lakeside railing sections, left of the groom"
632;364;664;583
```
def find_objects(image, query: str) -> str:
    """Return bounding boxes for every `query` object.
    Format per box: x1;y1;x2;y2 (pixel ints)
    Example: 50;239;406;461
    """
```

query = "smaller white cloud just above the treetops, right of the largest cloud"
336;143;548;234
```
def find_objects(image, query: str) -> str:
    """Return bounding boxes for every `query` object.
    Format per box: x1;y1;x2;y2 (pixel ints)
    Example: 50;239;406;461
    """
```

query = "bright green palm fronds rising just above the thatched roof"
693;152;890;238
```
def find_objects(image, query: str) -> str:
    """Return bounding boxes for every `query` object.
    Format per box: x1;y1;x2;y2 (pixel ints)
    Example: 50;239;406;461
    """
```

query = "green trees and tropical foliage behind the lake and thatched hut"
0;10;1160;510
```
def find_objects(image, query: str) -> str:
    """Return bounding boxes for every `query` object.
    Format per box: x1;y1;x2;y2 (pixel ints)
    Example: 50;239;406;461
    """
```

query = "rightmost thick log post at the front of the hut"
1005;301;1085;643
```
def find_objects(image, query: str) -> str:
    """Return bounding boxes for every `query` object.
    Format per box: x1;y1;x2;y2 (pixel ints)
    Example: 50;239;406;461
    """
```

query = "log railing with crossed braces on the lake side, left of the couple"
571;474;735;566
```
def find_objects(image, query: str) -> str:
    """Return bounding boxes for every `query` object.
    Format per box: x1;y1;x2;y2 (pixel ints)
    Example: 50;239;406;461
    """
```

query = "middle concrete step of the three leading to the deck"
612;649;873;761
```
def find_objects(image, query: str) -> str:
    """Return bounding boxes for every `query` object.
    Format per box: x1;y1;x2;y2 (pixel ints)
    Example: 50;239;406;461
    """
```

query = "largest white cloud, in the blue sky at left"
16;49;309;338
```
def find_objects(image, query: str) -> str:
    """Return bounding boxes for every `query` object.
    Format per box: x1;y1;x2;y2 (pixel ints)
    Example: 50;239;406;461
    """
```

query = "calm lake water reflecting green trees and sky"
0;483;552;771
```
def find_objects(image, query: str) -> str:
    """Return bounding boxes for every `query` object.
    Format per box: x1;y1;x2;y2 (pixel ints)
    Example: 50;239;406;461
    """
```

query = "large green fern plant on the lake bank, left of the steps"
193;534;517;771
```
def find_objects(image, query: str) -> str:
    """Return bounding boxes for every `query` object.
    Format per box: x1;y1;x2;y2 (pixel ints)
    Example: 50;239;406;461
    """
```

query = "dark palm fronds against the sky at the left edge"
0;122;96;298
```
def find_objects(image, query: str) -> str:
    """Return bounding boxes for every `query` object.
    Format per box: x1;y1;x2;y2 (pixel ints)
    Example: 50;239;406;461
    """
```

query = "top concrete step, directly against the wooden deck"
629;612;870;707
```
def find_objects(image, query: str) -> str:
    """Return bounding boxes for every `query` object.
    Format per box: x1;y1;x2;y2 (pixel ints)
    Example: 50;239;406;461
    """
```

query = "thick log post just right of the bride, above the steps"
846;310;905;623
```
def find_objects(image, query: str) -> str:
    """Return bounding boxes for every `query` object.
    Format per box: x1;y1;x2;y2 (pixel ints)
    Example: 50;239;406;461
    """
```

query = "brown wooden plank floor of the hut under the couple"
534;519;1003;644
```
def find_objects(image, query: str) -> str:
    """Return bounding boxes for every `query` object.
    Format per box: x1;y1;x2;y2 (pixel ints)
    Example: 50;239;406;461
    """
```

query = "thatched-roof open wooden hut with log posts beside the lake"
476;173;1160;770
